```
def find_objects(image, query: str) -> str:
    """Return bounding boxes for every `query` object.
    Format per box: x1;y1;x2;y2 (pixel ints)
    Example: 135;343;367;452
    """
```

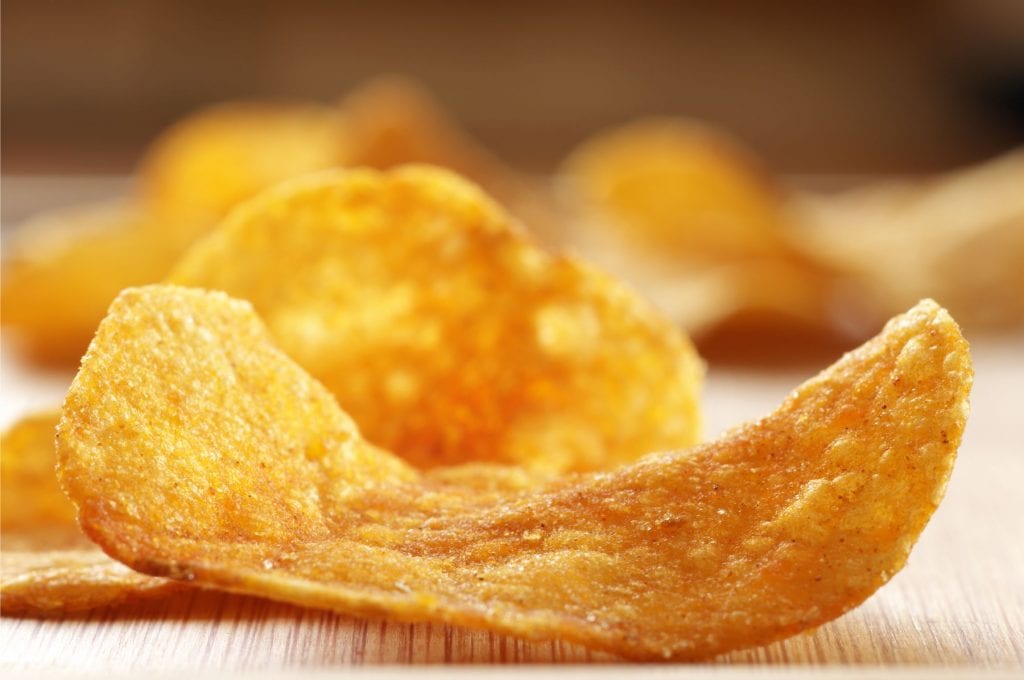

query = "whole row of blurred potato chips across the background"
8;78;1024;365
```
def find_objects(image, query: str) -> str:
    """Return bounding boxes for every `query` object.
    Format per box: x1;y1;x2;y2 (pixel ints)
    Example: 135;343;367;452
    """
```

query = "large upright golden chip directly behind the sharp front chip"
169;166;702;472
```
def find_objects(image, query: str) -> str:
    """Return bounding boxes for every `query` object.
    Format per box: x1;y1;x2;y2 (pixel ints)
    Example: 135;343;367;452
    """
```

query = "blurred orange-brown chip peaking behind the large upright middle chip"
341;76;564;245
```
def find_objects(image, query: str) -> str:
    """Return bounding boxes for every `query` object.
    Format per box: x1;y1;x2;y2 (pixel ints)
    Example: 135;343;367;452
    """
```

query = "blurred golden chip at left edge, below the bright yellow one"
2;202;188;365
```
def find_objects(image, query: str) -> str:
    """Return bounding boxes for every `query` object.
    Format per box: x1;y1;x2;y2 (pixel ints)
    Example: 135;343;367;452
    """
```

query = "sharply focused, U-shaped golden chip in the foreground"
58;287;972;660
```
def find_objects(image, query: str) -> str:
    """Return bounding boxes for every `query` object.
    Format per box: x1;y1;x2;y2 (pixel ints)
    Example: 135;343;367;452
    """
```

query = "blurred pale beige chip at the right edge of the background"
794;150;1024;327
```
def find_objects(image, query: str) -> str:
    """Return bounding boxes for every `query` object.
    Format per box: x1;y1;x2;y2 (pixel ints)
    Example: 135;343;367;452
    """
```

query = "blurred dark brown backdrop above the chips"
2;0;1024;175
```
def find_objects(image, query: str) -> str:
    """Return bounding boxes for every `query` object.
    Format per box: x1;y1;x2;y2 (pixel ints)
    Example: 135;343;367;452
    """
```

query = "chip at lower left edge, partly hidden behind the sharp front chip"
0;413;186;614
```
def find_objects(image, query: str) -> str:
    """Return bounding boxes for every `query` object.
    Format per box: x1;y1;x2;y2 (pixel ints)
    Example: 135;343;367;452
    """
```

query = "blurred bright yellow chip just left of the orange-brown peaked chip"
140;101;346;225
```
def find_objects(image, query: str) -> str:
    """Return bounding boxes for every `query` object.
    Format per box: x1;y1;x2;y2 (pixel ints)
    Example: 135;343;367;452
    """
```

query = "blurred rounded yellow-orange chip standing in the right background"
563;118;783;259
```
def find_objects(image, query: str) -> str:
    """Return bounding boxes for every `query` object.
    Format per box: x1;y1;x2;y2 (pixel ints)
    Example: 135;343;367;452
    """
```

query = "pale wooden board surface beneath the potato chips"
0;178;1024;677
